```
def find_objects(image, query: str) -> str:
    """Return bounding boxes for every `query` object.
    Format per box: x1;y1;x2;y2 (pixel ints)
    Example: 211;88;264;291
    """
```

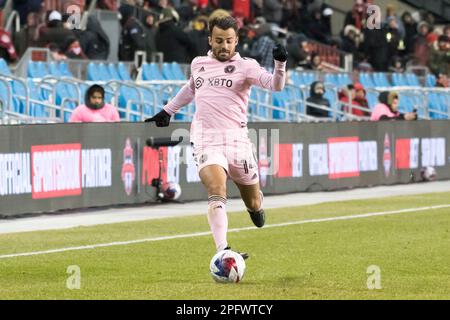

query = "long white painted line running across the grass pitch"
0;204;450;259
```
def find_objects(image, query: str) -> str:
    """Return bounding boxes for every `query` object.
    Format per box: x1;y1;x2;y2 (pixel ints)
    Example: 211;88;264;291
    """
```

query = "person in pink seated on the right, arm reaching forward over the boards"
370;91;417;121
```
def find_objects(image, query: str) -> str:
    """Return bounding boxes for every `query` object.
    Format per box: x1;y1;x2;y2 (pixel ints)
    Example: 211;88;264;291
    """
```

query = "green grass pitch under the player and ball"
0;193;450;300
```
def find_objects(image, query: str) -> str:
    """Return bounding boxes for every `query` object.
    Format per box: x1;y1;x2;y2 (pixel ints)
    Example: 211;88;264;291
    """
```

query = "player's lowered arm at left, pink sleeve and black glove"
145;77;195;127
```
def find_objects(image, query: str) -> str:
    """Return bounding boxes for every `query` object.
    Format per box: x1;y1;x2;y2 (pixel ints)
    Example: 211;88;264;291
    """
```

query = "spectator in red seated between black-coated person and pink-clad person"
339;82;370;117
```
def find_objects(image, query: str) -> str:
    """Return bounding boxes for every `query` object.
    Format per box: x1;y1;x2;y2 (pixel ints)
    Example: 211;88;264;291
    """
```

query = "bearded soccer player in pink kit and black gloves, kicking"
146;16;287;258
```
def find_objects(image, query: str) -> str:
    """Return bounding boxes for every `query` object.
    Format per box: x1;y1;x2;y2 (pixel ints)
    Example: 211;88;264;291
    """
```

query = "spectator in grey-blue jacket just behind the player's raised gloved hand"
249;23;276;70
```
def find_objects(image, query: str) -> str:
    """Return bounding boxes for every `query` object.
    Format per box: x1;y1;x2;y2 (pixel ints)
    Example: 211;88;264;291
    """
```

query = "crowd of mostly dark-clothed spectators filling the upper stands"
0;0;450;76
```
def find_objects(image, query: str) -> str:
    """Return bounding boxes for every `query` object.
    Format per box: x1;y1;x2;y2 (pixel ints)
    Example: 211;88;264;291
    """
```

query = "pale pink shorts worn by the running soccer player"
194;141;259;185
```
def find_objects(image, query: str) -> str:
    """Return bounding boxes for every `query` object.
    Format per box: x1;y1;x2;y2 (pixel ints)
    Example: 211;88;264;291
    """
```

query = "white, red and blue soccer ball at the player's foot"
209;250;245;283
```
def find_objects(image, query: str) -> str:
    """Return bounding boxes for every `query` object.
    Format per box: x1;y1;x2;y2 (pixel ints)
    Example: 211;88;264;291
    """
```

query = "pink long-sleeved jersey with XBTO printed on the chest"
164;51;286;145
